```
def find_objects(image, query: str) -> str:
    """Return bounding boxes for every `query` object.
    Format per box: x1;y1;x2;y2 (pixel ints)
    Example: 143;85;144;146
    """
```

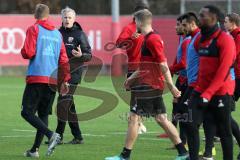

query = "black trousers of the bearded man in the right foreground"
186;91;233;160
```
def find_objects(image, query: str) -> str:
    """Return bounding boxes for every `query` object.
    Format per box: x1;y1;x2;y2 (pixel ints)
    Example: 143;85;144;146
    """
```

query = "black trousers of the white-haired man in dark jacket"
56;84;83;140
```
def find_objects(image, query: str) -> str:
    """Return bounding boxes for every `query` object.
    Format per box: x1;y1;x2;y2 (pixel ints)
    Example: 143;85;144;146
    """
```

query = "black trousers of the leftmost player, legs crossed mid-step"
21;84;56;150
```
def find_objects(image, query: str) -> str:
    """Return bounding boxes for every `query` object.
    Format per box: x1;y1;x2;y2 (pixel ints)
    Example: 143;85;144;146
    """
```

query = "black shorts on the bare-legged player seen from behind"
131;85;166;117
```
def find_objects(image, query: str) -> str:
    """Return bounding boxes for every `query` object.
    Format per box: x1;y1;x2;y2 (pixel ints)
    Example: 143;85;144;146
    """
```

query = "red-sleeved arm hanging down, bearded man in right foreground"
201;35;236;101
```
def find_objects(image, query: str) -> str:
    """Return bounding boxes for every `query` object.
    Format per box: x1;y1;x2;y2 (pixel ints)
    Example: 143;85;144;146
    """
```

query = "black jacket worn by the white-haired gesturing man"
59;22;92;84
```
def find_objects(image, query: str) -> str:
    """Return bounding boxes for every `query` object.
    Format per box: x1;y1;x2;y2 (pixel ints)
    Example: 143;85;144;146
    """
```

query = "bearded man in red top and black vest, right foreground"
186;5;236;160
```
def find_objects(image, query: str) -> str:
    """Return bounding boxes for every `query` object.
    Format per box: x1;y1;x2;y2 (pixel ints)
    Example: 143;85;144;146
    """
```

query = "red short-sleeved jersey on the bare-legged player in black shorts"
140;31;167;90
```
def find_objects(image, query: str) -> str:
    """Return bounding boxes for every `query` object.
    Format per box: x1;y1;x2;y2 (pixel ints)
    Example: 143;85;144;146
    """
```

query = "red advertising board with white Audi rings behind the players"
0;15;178;66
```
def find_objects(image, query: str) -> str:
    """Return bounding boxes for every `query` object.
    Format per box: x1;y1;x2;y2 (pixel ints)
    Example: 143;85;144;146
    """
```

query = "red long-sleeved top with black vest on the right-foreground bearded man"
194;29;236;100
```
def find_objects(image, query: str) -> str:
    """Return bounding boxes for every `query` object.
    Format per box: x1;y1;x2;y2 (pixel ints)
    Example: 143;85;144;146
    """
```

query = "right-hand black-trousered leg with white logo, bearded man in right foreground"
211;95;233;160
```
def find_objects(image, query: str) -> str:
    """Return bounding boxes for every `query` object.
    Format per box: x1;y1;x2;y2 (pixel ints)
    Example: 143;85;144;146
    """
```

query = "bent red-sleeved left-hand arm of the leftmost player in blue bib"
21;25;38;59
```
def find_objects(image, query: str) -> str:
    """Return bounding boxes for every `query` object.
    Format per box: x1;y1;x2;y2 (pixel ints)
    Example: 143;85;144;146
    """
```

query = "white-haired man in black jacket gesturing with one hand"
56;7;92;144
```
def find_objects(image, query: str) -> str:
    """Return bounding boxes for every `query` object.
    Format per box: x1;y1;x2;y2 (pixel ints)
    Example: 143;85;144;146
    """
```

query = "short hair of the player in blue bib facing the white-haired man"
34;3;50;19
